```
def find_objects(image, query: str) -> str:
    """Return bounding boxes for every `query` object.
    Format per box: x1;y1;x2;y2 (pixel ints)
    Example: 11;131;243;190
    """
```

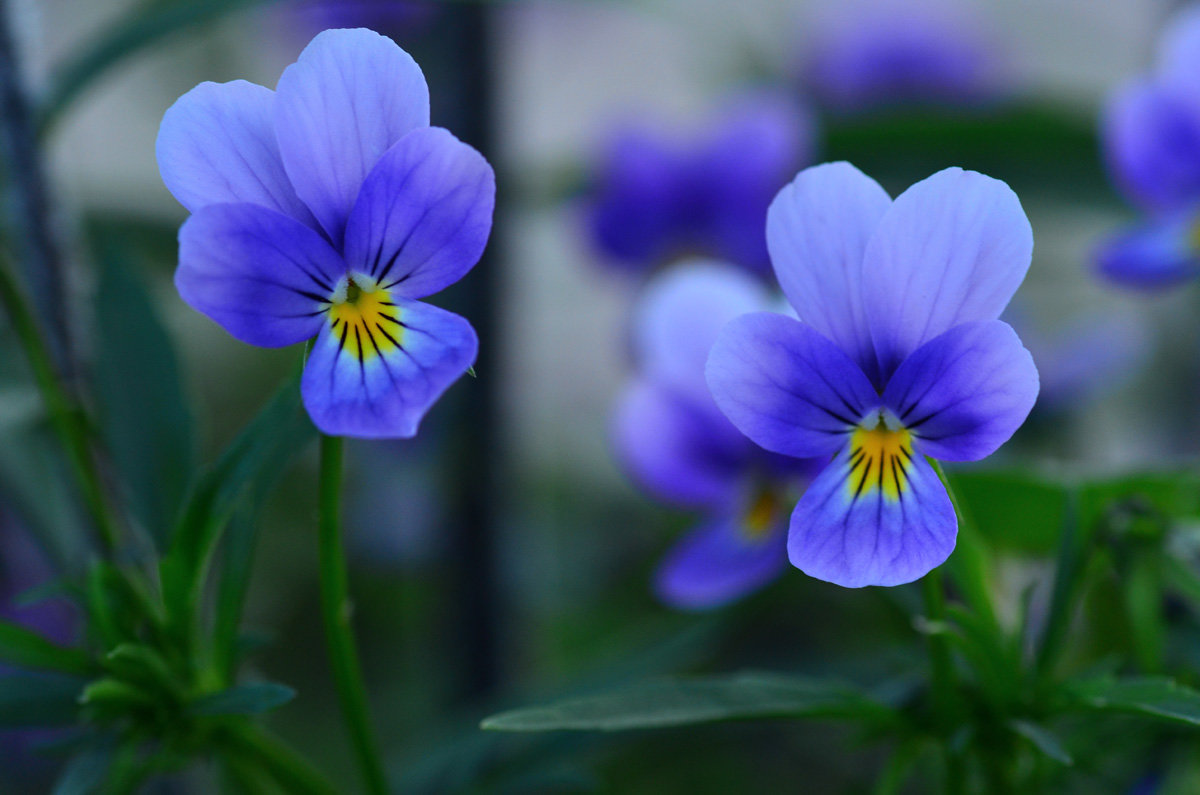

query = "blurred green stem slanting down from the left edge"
0;252;118;551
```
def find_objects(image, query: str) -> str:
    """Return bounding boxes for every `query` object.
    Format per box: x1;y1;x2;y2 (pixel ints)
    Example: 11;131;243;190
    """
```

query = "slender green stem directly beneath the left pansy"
317;435;388;795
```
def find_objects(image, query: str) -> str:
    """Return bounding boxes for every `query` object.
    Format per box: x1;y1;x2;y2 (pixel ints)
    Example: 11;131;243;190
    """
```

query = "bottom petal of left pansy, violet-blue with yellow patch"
300;299;479;438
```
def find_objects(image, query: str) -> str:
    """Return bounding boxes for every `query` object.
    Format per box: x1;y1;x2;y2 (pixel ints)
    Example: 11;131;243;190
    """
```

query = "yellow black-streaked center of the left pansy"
329;275;404;364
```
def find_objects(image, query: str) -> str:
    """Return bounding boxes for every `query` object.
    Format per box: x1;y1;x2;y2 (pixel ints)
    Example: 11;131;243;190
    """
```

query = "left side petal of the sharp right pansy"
707;312;880;458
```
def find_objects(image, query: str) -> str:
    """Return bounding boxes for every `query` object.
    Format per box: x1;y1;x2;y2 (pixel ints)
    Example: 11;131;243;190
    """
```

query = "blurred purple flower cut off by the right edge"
1096;7;1200;288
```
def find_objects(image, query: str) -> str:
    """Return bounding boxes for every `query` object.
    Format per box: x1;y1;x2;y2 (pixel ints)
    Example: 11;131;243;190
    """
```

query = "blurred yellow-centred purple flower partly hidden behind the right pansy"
613;262;814;609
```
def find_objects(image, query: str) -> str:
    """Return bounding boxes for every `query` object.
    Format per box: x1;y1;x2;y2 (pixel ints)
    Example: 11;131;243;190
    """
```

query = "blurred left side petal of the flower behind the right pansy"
612;379;752;508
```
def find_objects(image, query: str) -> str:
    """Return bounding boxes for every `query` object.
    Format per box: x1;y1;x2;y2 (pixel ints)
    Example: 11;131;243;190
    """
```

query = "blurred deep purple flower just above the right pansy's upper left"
587;91;812;275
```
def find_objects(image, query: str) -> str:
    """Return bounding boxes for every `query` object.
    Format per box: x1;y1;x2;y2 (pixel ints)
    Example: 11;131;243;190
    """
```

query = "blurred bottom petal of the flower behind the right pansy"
654;516;787;610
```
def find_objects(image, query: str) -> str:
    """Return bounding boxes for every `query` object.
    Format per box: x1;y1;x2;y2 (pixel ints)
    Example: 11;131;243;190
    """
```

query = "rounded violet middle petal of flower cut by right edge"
1100;79;1200;210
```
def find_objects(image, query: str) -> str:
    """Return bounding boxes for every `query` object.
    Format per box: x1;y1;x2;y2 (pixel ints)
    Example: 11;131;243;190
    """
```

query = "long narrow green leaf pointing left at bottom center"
481;673;893;731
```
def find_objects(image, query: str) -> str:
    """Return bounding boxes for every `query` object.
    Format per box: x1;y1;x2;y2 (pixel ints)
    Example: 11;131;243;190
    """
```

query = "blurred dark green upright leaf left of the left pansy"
95;246;196;549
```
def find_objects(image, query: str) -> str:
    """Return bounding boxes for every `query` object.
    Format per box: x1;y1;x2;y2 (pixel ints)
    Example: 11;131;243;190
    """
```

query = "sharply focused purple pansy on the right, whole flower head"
707;163;1038;587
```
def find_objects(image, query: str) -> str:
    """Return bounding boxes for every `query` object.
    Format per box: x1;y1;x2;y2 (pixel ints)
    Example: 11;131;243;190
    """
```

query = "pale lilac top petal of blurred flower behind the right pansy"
634;261;770;405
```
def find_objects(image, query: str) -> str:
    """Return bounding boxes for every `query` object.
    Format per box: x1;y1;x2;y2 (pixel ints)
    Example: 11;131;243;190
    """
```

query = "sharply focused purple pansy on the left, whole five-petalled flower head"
157;29;496;438
